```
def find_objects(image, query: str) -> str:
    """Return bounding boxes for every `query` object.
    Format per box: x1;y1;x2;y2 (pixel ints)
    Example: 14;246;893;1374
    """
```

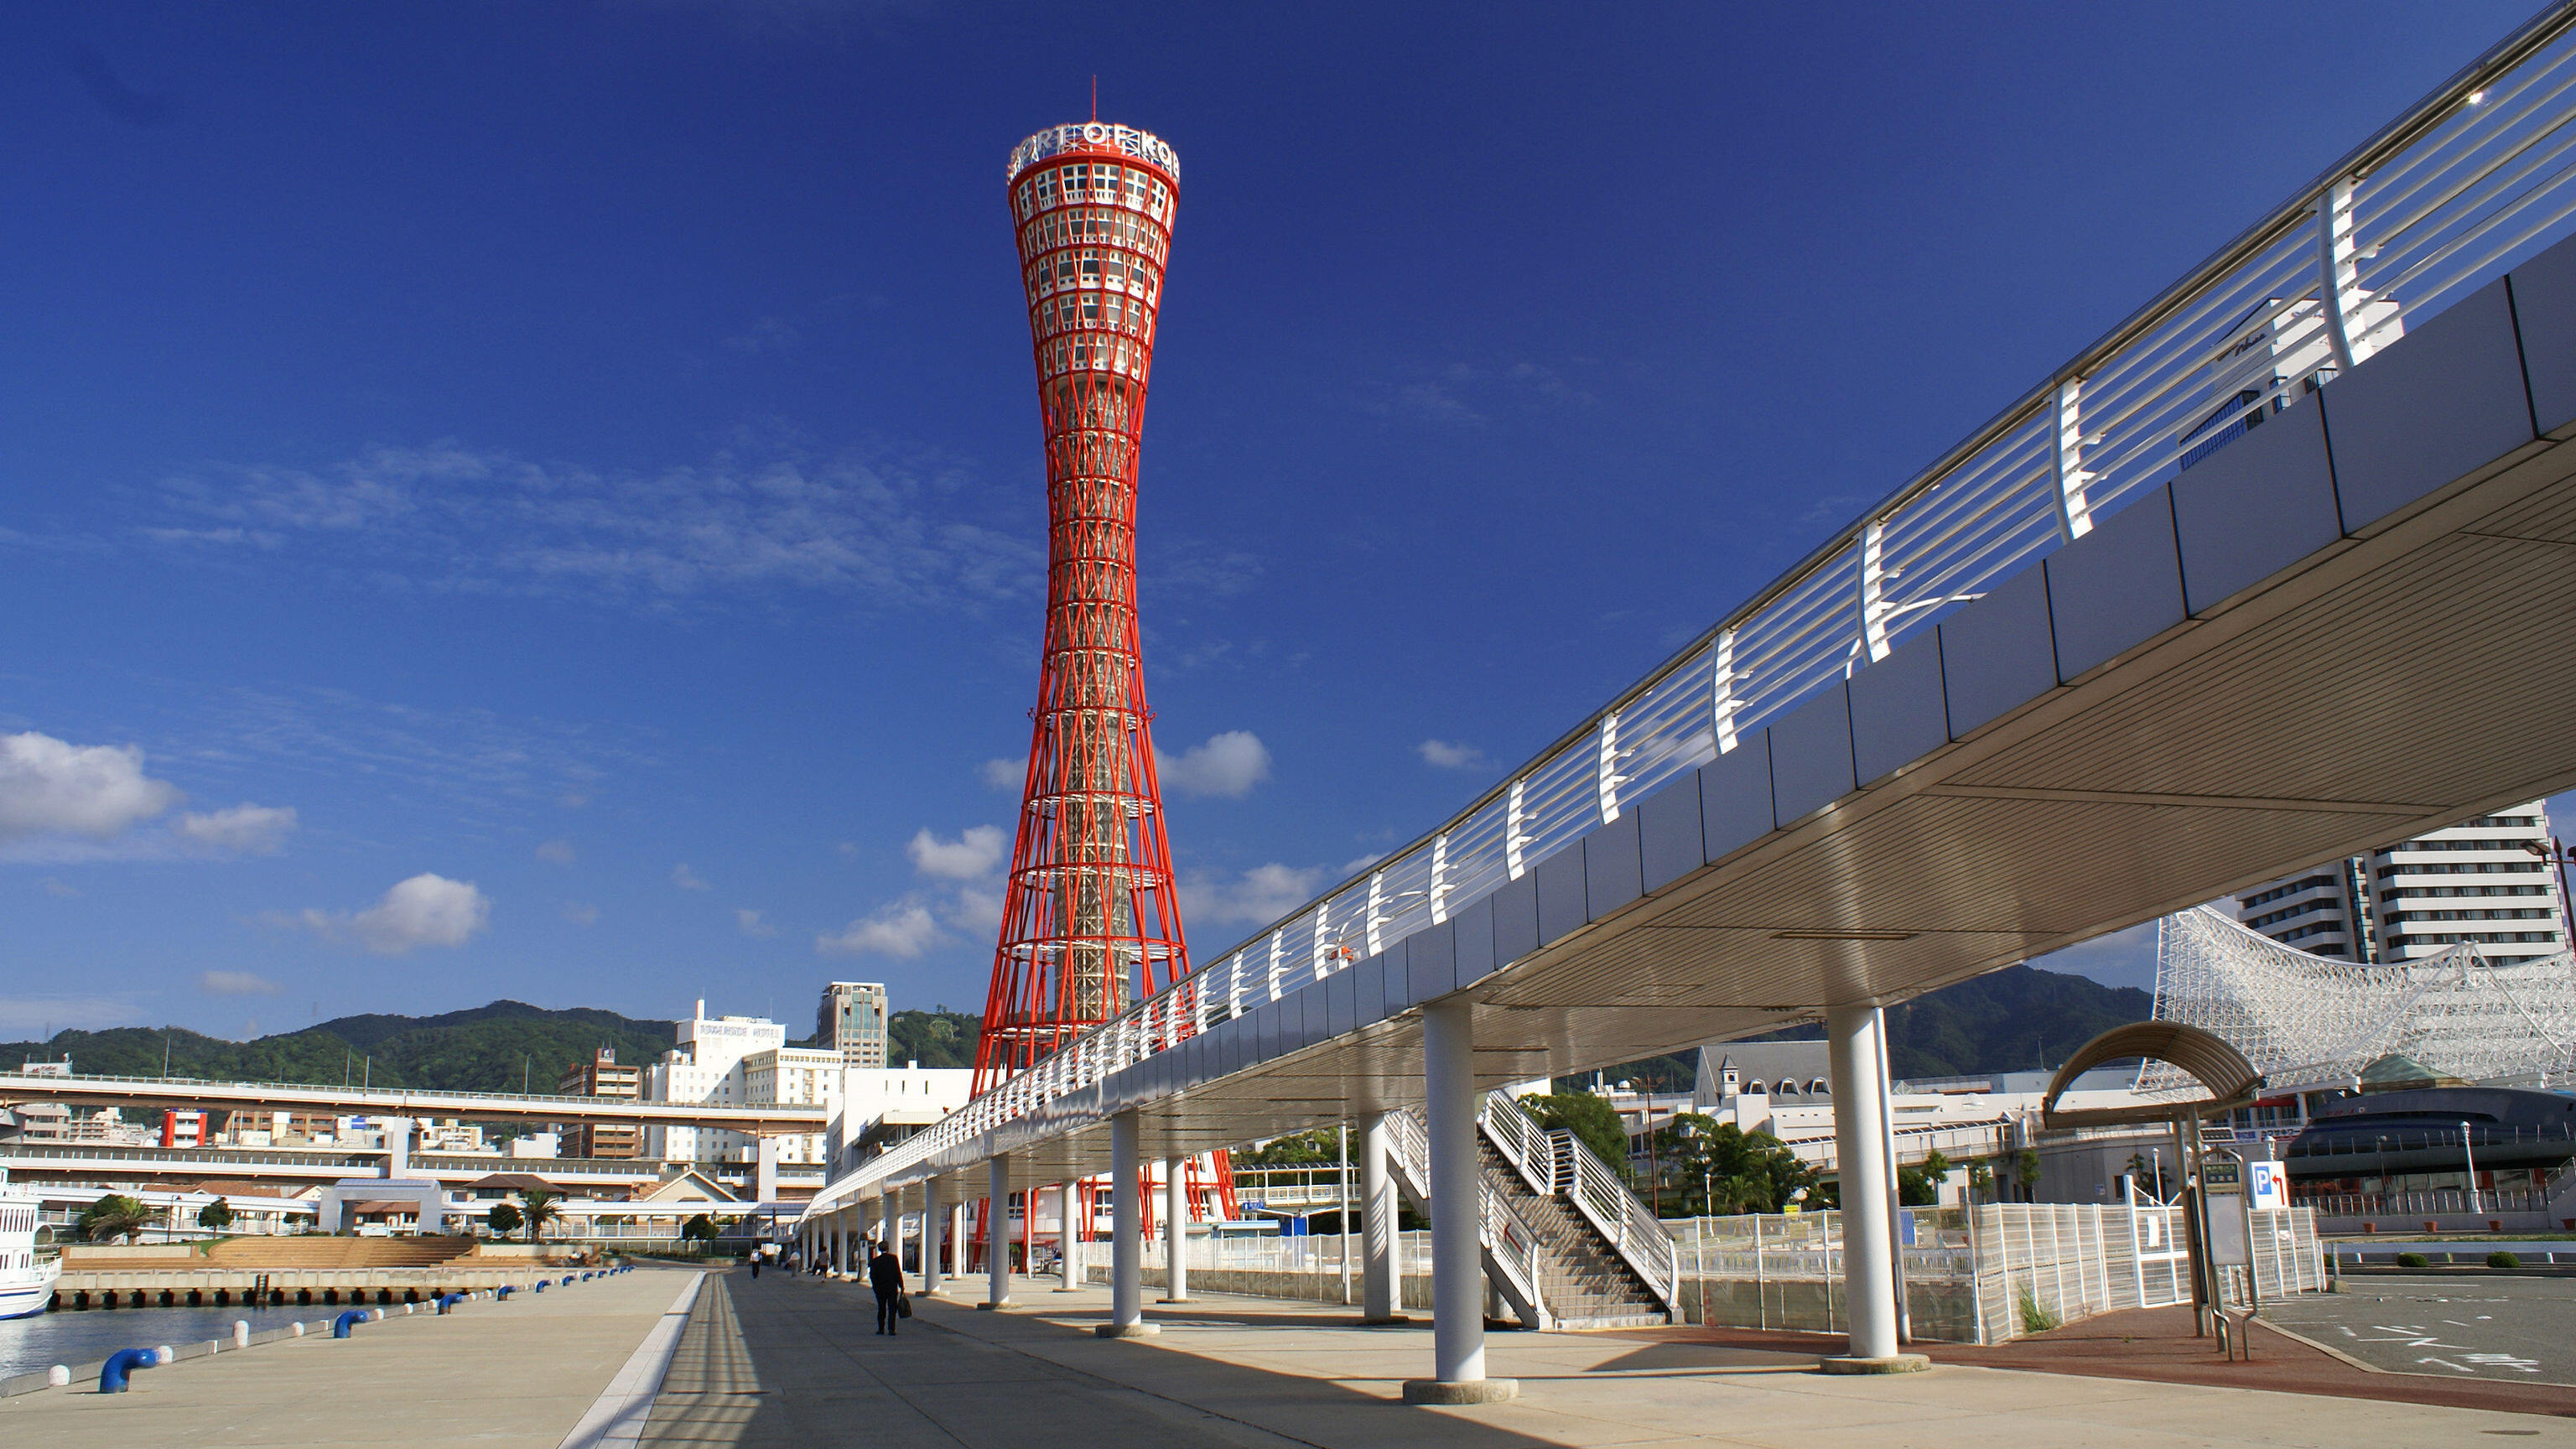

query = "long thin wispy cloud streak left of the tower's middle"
132;441;1046;609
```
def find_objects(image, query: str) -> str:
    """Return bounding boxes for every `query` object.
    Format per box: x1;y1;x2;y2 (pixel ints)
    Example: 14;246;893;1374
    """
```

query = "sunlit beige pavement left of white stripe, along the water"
0;1269;693;1449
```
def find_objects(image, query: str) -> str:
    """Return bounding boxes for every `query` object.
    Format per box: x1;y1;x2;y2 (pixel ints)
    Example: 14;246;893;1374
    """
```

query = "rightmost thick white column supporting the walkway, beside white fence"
1824;1005;1927;1374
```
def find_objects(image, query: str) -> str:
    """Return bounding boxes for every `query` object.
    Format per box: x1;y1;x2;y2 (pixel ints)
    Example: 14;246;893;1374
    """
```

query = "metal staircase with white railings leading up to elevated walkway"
1389;1091;1677;1327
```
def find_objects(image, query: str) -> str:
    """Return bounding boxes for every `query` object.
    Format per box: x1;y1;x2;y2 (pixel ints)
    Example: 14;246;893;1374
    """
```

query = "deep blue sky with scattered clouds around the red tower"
0;0;2527;1036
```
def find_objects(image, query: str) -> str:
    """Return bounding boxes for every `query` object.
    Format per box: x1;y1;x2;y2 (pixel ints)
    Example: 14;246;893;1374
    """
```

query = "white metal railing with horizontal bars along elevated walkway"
808;0;2576;1201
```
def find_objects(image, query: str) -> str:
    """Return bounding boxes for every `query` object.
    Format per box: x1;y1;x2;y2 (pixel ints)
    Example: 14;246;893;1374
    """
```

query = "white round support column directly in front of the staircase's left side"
1404;995;1519;1405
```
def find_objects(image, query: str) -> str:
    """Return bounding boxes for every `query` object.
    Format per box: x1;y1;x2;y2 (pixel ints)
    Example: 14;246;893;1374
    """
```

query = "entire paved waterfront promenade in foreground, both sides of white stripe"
0;1253;2576;1449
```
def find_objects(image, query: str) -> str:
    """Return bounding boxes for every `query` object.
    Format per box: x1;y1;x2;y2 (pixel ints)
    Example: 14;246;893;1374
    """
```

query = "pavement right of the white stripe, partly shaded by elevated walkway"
644;1274;2576;1449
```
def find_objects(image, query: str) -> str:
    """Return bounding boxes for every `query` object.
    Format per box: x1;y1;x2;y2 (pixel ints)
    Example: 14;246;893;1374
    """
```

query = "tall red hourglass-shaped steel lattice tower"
974;122;1190;1091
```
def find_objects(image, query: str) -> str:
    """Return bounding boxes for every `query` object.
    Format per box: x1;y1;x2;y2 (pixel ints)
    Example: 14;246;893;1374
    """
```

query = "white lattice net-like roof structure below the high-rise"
2138;905;2576;1096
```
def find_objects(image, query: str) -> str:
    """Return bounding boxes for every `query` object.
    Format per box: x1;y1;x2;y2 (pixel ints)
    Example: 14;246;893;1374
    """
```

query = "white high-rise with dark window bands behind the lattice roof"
2231;799;2568;964
